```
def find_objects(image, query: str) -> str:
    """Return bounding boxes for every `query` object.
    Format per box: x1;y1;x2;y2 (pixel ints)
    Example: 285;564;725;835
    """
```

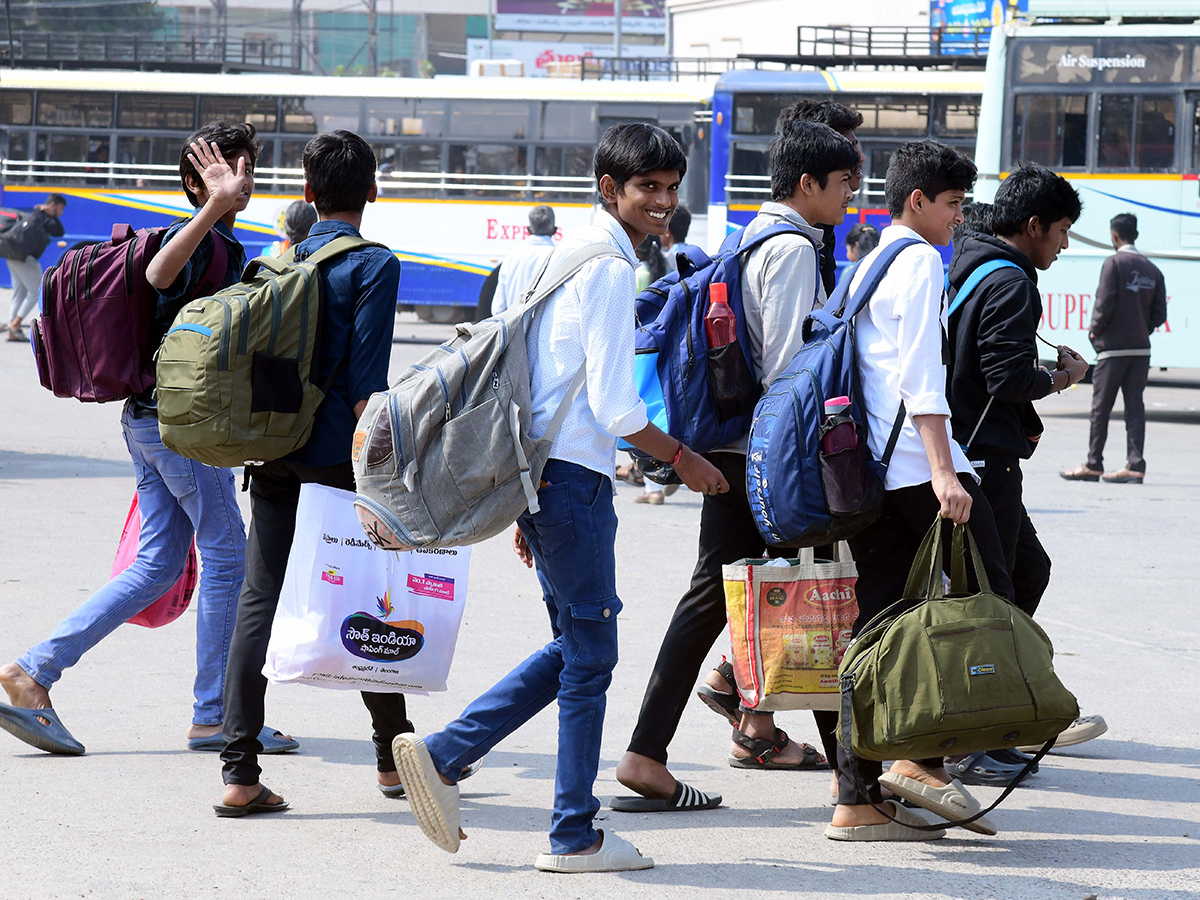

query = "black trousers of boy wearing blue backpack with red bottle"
629;452;838;763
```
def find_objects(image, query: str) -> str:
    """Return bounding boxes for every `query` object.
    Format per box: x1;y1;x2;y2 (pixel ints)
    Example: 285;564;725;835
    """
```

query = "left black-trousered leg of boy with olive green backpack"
221;462;300;805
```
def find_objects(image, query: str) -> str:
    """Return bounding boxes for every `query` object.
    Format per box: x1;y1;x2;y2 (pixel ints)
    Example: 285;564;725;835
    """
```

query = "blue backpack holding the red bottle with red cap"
619;222;816;484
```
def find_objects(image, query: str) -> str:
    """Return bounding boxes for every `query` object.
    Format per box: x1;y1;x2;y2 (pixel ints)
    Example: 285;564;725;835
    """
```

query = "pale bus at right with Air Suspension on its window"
976;15;1200;368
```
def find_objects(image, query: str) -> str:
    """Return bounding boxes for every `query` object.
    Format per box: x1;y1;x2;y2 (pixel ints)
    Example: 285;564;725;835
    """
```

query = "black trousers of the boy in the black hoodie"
971;456;1050;616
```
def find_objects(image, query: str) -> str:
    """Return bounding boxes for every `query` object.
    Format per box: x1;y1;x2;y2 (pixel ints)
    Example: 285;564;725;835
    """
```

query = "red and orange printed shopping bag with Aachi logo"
722;541;858;712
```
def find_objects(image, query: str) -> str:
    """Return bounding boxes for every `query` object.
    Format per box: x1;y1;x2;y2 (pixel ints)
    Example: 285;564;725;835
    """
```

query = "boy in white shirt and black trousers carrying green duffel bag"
826;140;1013;841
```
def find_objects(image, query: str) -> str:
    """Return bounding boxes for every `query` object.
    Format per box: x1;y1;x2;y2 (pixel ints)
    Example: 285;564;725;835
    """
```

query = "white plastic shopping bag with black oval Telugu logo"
263;485;470;694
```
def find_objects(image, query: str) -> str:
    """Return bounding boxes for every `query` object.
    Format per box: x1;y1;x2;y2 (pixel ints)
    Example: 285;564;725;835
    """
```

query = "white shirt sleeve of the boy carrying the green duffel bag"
889;248;950;416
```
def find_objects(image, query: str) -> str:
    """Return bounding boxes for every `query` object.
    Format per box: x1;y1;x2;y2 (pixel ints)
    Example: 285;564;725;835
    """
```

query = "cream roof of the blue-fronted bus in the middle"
714;68;984;94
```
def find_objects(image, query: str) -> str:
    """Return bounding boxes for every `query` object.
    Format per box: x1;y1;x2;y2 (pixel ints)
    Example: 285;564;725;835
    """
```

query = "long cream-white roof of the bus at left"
0;68;713;104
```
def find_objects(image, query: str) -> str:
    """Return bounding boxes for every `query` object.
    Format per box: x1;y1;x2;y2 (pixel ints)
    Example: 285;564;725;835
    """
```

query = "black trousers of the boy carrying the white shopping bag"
221;460;413;785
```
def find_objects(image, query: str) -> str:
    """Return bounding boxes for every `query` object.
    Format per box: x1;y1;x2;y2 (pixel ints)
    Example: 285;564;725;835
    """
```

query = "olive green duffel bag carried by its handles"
838;518;1079;760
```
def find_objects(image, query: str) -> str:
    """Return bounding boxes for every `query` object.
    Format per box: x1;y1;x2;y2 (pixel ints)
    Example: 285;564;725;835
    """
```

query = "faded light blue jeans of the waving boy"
17;407;246;725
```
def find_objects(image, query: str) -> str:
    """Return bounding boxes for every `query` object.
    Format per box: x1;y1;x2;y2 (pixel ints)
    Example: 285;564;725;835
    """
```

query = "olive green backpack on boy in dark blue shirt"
155;236;388;466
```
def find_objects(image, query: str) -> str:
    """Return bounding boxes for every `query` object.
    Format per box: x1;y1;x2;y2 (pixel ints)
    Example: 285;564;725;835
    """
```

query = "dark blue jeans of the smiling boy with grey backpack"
425;460;622;853
